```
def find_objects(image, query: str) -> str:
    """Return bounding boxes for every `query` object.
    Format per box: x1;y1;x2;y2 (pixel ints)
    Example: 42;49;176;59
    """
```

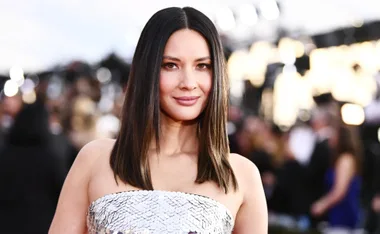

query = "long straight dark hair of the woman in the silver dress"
110;7;238;193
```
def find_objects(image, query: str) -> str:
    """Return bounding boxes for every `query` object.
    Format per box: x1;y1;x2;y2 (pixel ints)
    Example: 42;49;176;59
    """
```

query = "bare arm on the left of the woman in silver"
49;141;98;234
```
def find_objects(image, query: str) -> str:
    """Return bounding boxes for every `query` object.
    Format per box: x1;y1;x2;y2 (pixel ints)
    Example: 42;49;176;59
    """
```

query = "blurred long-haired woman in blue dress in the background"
311;125;361;233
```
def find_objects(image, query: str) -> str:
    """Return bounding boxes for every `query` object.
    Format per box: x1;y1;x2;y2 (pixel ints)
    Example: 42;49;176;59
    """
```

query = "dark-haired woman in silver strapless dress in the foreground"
50;7;267;234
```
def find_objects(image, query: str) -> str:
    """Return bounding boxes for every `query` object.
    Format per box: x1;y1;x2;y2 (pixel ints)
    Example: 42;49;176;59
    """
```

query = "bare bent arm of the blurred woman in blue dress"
311;154;356;216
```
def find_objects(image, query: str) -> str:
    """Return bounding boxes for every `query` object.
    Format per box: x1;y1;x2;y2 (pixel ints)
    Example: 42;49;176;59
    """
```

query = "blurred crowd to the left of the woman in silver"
0;56;128;233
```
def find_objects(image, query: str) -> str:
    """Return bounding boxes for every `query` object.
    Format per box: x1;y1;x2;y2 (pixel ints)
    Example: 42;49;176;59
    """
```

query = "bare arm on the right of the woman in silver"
233;154;268;234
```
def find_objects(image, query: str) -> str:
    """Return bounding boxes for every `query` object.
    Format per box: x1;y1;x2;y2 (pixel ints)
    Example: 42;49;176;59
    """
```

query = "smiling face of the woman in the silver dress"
160;29;212;121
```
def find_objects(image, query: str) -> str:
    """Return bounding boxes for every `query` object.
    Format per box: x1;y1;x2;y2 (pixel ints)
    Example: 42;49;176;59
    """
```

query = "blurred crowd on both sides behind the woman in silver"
0;55;380;233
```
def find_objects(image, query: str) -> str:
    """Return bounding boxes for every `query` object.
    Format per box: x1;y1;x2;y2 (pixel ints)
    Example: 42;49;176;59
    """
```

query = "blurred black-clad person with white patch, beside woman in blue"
277;116;331;229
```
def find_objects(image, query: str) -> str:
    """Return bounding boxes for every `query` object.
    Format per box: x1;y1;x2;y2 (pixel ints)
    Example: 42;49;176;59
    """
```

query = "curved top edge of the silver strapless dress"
89;189;235;221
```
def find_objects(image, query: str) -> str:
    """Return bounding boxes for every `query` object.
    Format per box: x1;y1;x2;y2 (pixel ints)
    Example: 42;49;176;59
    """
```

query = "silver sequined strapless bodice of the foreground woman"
87;190;234;234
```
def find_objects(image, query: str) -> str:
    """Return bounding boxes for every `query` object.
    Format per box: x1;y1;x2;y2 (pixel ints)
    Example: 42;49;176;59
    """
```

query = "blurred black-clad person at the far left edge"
0;96;65;234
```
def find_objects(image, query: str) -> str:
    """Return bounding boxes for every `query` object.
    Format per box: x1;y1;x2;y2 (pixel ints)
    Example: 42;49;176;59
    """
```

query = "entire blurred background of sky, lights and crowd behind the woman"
0;0;380;233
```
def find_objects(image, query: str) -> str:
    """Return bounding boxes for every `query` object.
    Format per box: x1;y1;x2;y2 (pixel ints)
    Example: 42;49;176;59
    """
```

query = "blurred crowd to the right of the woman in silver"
229;93;380;233
